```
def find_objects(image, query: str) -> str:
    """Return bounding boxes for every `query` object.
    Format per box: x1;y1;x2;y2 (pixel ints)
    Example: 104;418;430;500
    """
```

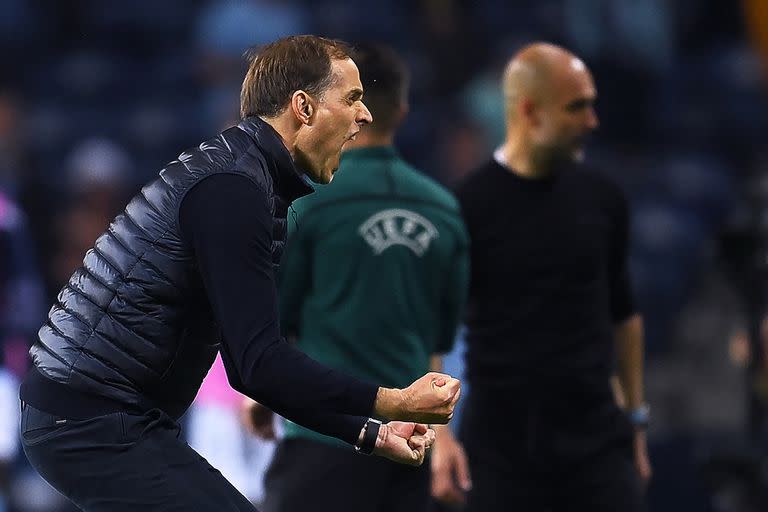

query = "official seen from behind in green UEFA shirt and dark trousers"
264;46;469;512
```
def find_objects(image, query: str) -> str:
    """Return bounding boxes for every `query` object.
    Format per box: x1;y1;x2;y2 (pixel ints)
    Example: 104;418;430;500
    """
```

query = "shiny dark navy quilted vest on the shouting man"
30;118;312;417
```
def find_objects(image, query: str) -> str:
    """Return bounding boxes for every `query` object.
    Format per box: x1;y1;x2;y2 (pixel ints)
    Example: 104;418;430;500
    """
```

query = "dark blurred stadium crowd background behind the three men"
0;0;768;512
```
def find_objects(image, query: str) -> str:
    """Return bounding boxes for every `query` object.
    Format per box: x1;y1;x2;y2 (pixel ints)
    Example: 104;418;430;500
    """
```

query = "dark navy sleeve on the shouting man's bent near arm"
179;174;378;443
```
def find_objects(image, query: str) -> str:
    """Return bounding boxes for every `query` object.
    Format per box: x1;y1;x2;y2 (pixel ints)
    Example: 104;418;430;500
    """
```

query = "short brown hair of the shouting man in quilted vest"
240;35;352;118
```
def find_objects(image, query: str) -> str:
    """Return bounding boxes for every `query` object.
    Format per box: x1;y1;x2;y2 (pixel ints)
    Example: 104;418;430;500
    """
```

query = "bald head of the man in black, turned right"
502;43;598;167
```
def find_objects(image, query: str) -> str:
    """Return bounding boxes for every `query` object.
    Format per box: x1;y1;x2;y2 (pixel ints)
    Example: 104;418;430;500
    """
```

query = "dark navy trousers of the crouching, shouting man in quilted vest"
21;403;256;512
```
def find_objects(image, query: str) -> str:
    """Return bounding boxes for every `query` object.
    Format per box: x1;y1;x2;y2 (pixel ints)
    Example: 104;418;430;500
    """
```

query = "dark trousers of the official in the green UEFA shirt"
263;439;430;512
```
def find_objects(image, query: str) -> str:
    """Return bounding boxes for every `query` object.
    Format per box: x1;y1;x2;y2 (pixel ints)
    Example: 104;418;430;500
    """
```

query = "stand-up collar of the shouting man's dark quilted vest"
238;117;315;203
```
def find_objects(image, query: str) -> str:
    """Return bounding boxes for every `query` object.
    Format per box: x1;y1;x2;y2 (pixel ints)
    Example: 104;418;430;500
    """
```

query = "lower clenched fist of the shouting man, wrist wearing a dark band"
373;421;435;466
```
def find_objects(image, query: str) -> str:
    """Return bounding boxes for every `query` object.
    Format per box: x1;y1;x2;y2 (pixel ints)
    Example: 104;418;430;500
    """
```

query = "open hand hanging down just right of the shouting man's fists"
432;426;472;505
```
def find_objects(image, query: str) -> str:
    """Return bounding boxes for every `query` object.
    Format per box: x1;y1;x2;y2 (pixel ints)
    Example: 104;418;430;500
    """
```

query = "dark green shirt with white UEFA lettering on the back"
279;147;469;442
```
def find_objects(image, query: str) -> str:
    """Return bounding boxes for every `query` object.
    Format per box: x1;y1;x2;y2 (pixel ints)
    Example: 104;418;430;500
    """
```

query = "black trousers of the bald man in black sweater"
460;389;645;512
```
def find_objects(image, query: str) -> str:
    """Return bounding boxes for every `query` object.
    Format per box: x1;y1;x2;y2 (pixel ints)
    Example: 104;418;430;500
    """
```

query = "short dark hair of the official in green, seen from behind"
352;43;410;133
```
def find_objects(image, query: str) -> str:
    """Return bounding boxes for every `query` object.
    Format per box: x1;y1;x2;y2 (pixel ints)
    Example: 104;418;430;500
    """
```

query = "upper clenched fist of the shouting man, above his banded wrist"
374;372;461;424
